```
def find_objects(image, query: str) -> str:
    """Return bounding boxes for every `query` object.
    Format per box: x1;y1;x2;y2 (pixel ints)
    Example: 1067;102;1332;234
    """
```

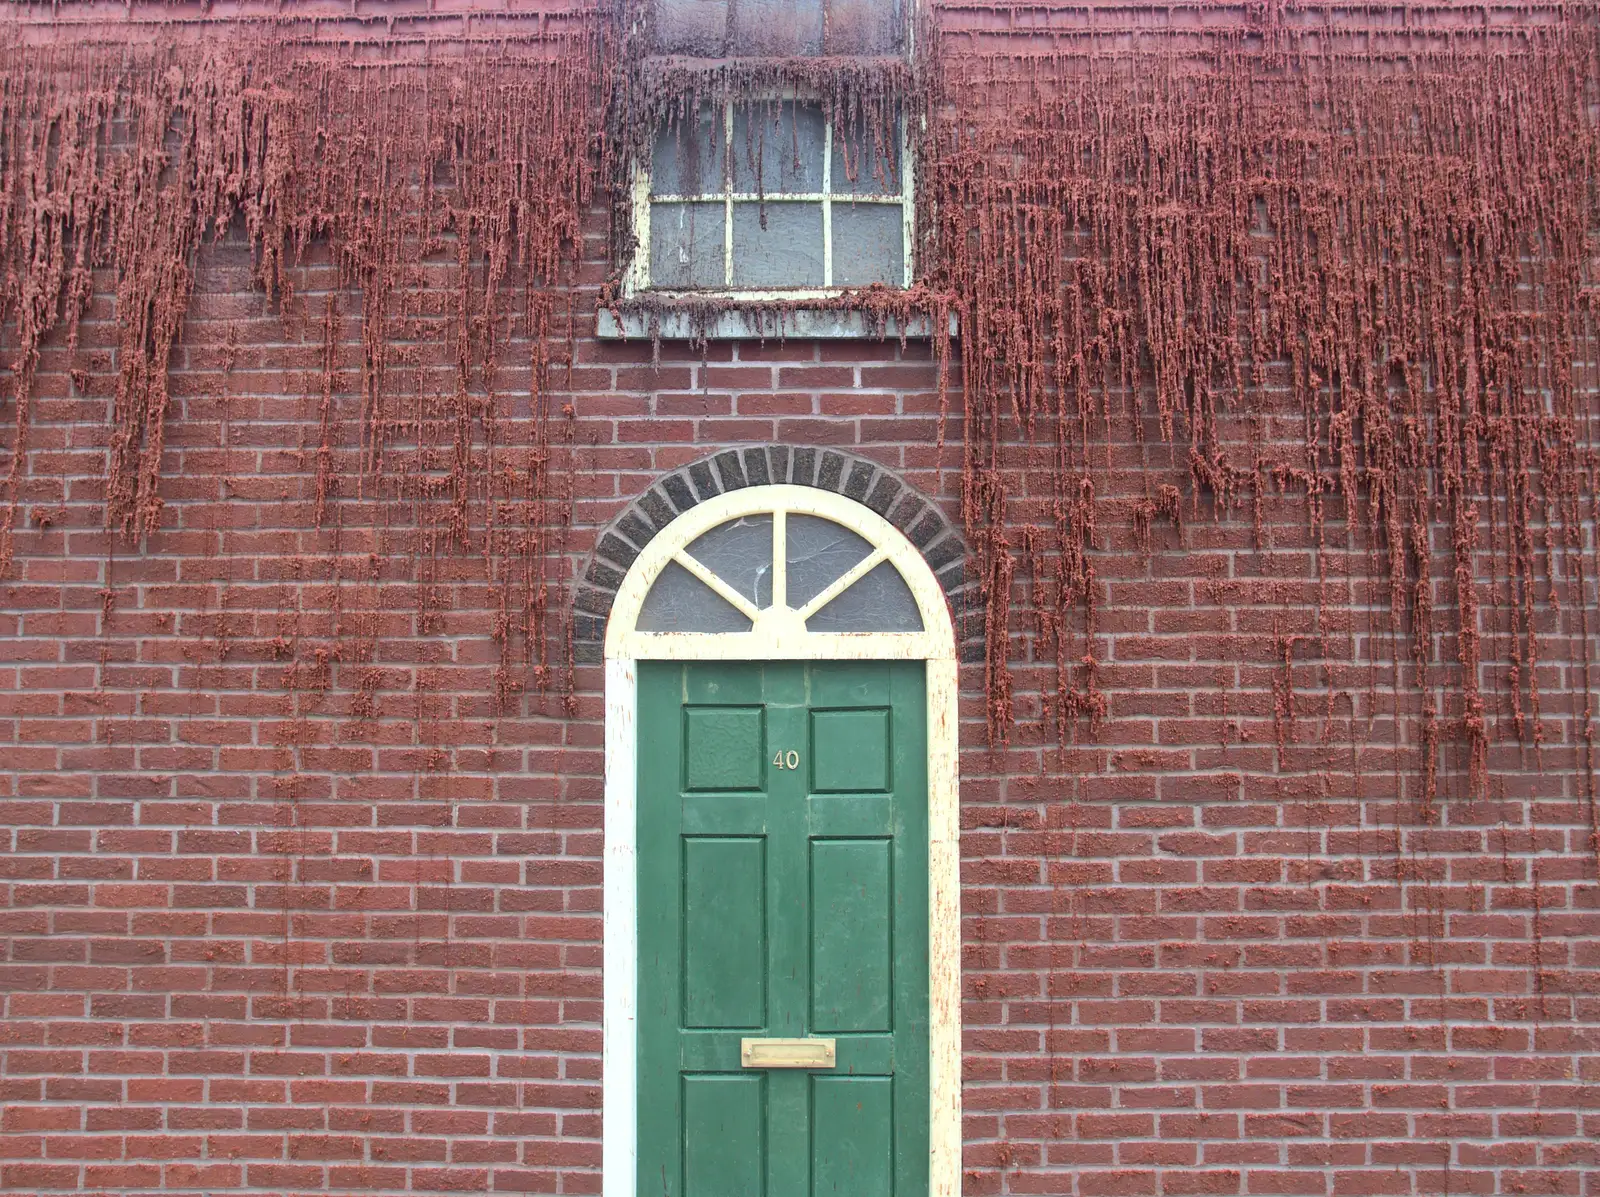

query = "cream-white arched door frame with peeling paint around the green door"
600;485;962;1197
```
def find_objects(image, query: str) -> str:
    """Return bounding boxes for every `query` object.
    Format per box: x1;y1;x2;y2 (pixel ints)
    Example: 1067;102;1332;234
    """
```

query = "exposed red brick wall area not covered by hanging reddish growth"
0;2;1600;1197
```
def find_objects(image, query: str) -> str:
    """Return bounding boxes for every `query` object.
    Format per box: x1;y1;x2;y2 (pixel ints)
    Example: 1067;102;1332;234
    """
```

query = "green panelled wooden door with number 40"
638;661;928;1197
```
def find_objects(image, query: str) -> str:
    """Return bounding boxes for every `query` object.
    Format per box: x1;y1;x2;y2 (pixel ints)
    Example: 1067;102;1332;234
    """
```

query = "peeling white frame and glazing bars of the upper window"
622;93;917;304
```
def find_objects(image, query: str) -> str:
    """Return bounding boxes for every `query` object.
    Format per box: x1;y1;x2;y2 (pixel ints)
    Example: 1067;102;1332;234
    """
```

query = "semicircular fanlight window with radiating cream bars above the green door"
637;510;923;632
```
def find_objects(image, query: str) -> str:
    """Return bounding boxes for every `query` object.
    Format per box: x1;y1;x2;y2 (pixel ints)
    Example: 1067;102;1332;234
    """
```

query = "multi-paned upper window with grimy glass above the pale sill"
630;98;914;301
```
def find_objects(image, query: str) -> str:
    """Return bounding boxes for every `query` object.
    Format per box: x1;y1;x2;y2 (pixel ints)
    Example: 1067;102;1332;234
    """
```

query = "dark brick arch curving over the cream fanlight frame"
573;445;984;664
